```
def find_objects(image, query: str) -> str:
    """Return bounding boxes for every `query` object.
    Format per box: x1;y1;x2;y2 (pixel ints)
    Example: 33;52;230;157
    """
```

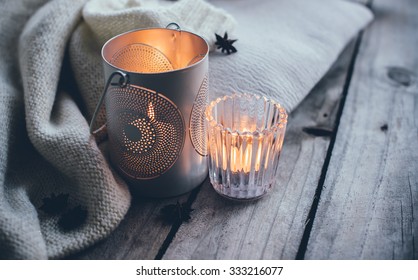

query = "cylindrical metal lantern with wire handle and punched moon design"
90;24;209;197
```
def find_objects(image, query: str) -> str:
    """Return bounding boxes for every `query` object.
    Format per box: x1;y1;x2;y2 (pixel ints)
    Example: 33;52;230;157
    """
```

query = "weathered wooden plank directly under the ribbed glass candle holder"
164;40;354;259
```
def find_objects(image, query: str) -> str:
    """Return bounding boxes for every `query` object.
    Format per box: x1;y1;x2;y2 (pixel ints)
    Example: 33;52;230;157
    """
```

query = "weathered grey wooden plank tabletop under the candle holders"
71;0;418;259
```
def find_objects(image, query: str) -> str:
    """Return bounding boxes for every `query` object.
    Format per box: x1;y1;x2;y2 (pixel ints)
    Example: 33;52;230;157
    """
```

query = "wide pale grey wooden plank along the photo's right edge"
305;0;418;259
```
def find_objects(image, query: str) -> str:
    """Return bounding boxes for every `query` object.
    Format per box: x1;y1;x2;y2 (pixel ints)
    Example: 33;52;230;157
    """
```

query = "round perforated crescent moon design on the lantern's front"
106;85;185;179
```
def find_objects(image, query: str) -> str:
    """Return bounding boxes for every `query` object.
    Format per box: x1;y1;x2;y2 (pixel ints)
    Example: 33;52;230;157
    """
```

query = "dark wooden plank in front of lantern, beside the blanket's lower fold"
69;194;190;260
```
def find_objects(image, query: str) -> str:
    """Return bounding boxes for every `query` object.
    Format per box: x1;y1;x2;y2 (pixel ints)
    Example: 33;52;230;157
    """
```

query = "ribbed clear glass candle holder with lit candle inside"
205;94;287;200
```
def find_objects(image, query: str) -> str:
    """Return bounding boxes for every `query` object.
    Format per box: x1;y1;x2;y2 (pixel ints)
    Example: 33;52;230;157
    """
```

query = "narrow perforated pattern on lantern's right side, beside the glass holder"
189;74;209;156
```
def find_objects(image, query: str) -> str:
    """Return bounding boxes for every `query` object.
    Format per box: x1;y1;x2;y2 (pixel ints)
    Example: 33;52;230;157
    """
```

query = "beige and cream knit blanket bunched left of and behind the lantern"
0;0;371;259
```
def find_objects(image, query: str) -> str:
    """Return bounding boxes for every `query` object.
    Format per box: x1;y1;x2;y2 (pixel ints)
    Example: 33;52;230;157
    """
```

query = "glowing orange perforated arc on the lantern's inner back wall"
110;44;173;73
